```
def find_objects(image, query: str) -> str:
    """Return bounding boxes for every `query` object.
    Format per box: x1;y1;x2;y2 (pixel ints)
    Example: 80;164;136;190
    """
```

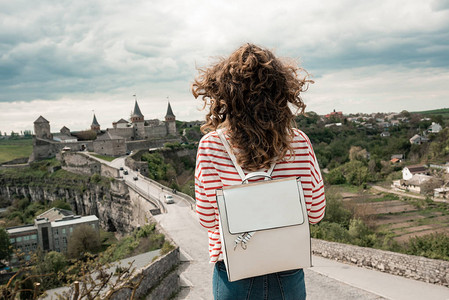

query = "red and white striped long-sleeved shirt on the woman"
195;129;326;263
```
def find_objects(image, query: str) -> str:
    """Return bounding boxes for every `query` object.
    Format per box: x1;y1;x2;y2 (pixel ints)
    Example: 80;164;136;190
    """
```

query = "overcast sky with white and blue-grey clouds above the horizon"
0;0;449;133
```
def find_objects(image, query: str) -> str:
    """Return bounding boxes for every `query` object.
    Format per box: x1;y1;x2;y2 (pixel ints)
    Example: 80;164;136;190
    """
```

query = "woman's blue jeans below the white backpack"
212;261;306;300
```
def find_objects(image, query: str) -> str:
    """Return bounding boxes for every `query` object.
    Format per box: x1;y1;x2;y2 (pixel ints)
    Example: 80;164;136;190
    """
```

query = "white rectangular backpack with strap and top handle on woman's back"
216;130;312;281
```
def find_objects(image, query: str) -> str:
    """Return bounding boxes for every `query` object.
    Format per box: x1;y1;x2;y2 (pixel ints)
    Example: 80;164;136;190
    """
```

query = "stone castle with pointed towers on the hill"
30;100;180;161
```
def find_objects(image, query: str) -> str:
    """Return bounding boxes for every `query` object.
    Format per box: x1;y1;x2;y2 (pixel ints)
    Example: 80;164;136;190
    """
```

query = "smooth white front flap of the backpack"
220;178;305;234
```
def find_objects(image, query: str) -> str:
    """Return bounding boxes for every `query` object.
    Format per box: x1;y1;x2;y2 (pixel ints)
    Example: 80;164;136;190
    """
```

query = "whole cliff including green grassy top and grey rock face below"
0;164;134;234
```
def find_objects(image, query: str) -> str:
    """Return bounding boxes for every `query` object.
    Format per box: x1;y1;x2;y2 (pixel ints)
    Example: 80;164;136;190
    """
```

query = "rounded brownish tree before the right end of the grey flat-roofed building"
67;224;101;258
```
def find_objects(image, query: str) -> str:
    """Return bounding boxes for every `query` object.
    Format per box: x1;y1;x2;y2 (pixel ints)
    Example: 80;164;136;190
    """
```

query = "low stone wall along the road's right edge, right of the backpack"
312;239;449;286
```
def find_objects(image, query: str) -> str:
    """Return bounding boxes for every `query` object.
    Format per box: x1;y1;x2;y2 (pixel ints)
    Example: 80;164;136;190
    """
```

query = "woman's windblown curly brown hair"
192;44;313;171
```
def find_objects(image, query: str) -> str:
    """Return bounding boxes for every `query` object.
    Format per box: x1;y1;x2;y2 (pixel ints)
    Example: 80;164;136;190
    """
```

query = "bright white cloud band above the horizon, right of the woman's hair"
304;66;449;114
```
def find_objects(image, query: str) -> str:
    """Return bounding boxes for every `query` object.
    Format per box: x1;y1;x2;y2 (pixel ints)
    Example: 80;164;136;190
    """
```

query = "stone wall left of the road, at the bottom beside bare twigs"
111;247;180;300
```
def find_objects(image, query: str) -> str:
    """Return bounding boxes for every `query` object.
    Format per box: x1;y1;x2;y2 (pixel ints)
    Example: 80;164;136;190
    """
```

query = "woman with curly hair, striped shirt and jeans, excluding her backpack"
192;44;326;300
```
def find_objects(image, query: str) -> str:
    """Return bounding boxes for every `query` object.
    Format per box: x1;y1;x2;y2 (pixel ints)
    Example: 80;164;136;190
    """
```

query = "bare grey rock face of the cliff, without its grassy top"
0;177;134;234
